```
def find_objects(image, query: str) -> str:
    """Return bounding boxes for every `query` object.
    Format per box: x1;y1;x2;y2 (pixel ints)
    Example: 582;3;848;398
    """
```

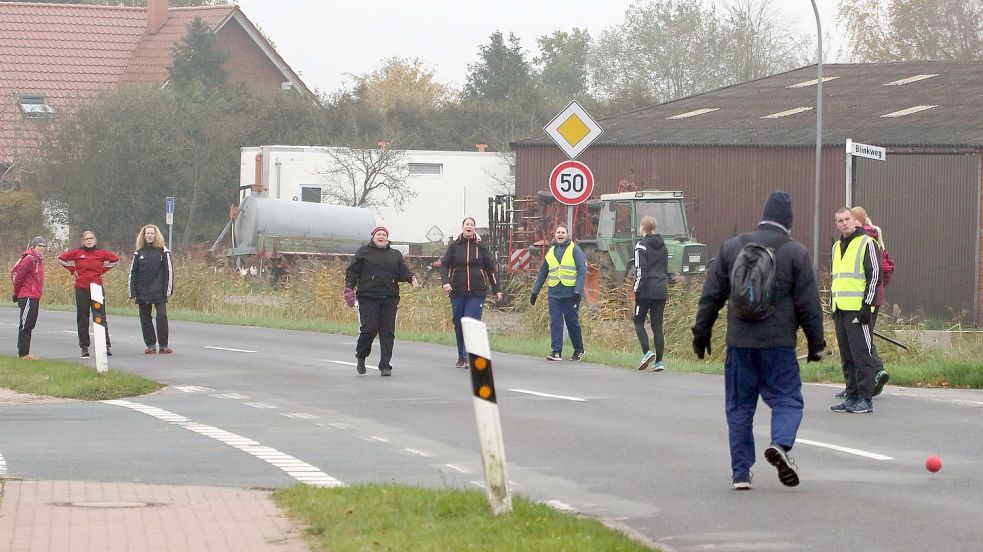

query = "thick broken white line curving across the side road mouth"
104;400;345;487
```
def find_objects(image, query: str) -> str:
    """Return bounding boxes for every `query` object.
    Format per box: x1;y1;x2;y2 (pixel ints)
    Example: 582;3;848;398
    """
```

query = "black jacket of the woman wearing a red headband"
345;242;413;299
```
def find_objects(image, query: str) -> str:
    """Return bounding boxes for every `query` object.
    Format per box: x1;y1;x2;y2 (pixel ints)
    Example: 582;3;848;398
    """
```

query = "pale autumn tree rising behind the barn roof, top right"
837;0;983;62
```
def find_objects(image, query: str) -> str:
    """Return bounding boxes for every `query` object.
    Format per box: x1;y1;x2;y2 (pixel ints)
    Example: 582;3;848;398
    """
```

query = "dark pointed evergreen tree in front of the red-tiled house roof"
167;17;229;90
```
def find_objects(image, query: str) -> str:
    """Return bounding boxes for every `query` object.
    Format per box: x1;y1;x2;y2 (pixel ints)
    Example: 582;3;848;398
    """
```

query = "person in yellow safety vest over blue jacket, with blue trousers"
529;225;587;362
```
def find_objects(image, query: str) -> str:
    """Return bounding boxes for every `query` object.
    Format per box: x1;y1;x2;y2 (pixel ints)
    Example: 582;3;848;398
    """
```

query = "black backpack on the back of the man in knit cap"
729;241;788;322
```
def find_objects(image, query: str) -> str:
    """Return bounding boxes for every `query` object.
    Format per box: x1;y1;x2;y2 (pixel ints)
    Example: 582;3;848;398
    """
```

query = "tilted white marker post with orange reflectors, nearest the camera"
461;318;512;516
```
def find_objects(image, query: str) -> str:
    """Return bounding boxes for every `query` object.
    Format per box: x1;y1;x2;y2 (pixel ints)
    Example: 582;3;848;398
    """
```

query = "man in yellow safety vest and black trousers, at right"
830;207;881;414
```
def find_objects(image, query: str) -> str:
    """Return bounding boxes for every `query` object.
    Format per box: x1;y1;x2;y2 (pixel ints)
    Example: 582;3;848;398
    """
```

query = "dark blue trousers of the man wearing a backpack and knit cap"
724;347;802;477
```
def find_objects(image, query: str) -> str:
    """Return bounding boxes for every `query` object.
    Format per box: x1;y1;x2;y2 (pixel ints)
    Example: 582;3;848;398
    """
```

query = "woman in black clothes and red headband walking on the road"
344;226;420;376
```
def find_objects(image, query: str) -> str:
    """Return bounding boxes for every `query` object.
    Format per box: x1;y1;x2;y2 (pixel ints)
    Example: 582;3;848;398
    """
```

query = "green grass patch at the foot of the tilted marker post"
273;485;652;552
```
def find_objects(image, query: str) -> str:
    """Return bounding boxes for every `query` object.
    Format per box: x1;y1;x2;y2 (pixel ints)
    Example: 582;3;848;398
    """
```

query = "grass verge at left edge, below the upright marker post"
0;356;163;401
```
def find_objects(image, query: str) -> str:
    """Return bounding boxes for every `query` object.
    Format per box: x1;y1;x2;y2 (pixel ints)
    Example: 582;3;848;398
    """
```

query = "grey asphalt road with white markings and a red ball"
0;307;983;552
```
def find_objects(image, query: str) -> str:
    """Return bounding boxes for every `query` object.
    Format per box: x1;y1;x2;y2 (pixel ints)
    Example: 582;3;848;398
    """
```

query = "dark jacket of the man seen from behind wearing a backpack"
694;222;826;351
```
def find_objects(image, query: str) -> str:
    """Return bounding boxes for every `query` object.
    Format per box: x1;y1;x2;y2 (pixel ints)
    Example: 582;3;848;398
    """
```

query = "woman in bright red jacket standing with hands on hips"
58;230;119;358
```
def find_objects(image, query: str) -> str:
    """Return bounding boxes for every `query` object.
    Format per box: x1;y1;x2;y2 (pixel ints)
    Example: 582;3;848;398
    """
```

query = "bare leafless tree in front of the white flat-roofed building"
320;147;417;210
